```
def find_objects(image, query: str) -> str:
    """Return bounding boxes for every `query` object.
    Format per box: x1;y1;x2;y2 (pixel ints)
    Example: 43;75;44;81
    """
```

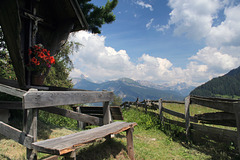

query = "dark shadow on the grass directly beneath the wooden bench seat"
77;139;128;160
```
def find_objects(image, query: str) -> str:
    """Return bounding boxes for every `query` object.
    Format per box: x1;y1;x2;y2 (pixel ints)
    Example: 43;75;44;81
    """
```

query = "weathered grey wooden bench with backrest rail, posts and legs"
0;84;137;160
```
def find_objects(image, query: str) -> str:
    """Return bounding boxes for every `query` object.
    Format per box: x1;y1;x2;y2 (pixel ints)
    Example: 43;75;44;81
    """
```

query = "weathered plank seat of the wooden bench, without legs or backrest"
32;122;137;155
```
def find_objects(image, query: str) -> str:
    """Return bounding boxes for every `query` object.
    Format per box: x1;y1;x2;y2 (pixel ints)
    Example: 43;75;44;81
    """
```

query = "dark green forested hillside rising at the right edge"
190;67;240;97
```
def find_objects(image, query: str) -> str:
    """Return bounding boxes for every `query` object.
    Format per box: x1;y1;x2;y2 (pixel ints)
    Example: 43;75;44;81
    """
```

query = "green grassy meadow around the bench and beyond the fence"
0;104;240;160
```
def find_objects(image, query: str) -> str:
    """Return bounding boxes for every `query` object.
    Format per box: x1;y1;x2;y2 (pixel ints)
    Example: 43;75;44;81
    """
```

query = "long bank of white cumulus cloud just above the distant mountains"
71;31;219;85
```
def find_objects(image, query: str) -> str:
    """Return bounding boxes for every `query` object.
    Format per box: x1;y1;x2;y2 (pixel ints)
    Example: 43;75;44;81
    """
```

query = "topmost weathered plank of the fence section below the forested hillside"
191;96;239;113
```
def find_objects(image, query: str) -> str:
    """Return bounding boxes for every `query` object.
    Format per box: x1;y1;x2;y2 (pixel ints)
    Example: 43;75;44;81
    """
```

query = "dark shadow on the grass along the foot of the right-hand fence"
161;120;240;160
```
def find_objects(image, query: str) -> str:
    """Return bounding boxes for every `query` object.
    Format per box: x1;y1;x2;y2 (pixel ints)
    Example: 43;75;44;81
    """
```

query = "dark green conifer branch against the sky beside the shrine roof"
78;0;118;33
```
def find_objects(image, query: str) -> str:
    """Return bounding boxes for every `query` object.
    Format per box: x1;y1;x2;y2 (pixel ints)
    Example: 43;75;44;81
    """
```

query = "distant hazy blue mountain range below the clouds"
73;76;193;101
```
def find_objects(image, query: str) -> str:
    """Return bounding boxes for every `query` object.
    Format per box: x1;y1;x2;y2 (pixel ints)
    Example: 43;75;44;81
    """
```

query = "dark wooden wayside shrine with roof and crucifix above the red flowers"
0;0;88;88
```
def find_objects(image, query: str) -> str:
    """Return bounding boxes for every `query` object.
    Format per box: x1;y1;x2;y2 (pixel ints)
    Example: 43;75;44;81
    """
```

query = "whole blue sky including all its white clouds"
70;0;240;86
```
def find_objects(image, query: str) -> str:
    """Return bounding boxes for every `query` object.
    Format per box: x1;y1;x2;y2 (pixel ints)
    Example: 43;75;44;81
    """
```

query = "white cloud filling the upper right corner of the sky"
158;0;240;48
